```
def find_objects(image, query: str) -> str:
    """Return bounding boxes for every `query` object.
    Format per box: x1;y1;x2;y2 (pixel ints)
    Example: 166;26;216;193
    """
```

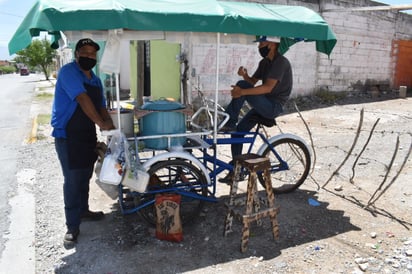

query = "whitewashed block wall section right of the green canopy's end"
317;1;412;91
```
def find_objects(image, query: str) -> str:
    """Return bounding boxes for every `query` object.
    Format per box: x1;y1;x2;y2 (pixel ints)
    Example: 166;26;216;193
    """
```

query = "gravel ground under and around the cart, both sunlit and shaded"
19;83;412;274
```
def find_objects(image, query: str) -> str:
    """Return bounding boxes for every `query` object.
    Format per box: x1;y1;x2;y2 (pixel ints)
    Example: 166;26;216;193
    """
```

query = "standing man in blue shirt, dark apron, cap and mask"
51;38;114;244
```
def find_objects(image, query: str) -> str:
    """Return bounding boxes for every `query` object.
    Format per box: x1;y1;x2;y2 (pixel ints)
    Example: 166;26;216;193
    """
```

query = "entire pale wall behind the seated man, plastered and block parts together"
192;0;412;104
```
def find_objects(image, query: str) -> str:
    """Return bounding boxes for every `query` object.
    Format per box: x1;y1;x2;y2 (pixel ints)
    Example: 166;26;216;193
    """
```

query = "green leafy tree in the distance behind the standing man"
14;37;56;80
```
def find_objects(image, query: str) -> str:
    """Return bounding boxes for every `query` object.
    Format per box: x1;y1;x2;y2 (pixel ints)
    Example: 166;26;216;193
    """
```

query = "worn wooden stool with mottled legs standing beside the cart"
224;154;279;252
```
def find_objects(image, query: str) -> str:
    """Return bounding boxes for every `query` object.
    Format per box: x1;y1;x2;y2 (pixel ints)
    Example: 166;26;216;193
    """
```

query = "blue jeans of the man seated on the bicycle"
226;80;283;157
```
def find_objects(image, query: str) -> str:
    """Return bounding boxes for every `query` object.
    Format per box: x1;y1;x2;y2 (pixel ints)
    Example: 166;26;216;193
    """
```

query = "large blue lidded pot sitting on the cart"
139;100;186;149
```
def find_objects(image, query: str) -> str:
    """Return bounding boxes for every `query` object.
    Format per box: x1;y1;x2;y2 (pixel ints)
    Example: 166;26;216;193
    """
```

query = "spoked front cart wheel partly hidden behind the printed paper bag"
135;159;208;225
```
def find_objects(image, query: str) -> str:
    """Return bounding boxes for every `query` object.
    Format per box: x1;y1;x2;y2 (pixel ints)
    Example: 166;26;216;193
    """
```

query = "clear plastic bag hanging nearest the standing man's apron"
99;131;128;185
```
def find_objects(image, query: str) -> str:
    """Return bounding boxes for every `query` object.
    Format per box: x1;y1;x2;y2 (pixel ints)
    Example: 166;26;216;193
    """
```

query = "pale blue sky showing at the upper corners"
0;0;412;60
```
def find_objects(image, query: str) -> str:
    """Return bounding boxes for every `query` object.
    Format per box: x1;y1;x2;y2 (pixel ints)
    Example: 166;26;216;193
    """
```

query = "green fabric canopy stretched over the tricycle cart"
9;0;336;55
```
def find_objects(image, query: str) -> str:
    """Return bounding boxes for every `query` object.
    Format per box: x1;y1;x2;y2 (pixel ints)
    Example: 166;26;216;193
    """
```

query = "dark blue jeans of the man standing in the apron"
55;138;94;229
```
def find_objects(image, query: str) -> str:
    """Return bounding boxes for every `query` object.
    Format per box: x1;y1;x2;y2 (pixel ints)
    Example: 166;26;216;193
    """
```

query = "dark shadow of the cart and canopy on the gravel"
56;190;360;273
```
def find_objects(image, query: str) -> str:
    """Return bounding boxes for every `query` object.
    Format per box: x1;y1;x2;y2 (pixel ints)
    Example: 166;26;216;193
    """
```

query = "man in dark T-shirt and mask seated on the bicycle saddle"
219;36;293;183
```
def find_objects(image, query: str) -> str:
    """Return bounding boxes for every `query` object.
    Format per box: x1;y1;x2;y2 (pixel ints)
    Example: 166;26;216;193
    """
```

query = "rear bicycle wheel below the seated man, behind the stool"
258;138;311;194
